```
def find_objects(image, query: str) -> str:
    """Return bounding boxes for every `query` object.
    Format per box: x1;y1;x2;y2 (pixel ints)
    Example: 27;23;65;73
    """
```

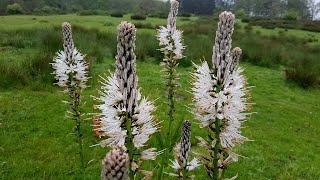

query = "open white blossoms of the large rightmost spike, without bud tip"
192;62;249;148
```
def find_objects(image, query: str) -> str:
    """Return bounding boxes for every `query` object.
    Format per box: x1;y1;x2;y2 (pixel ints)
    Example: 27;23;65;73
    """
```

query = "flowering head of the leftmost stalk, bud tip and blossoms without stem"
52;22;88;92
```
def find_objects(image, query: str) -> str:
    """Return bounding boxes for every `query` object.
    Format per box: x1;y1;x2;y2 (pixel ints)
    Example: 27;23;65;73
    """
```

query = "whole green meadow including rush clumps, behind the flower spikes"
0;15;320;179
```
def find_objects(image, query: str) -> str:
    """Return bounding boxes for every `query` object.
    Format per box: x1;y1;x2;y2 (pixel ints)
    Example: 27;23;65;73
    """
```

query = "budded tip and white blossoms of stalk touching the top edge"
157;0;185;61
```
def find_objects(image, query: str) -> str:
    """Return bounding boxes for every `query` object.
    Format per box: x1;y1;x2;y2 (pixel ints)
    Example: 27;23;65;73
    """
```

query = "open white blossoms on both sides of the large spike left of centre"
95;74;158;149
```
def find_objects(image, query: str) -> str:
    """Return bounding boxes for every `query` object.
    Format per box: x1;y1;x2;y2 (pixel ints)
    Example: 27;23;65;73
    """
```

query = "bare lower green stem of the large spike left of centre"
125;112;134;180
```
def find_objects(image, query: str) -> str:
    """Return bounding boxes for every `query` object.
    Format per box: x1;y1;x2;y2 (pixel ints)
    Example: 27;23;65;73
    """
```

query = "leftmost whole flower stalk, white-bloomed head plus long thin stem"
51;22;89;173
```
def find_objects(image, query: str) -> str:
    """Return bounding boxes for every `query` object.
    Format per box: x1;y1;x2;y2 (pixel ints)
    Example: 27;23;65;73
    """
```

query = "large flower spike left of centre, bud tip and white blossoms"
94;22;162;179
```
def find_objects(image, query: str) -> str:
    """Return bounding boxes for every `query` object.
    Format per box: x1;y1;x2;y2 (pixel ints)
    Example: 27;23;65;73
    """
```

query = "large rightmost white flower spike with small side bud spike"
192;12;252;179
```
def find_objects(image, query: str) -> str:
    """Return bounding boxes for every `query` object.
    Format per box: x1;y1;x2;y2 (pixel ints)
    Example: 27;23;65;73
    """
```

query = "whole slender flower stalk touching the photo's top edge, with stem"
157;0;185;179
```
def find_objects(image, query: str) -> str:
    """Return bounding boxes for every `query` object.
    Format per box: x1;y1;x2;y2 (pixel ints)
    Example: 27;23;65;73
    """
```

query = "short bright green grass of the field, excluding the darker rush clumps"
0;15;320;180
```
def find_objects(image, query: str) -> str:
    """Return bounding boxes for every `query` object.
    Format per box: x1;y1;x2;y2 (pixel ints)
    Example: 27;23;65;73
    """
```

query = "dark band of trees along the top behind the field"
0;0;320;19
